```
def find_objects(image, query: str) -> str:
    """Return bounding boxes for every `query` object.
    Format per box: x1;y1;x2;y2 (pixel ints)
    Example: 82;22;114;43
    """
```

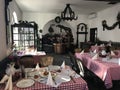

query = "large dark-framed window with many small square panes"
11;22;37;50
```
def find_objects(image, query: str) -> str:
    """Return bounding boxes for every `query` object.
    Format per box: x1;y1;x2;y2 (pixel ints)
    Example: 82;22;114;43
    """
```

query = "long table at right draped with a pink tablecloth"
75;53;120;88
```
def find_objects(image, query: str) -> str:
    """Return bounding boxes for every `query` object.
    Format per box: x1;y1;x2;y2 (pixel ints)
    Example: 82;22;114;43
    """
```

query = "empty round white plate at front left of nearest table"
16;79;35;88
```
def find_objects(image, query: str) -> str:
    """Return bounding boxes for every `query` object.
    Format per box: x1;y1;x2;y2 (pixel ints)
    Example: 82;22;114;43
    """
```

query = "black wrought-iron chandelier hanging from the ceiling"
61;4;78;21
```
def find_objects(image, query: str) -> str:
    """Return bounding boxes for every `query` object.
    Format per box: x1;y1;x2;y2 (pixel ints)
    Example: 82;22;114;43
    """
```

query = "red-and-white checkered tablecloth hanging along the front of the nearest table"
0;77;88;90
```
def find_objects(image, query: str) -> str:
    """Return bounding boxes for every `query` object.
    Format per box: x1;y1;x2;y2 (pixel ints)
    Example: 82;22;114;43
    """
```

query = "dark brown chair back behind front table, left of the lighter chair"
19;55;34;68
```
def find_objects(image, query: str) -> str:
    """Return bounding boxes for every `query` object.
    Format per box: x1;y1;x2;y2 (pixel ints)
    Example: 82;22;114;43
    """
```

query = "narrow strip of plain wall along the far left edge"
0;0;7;60
